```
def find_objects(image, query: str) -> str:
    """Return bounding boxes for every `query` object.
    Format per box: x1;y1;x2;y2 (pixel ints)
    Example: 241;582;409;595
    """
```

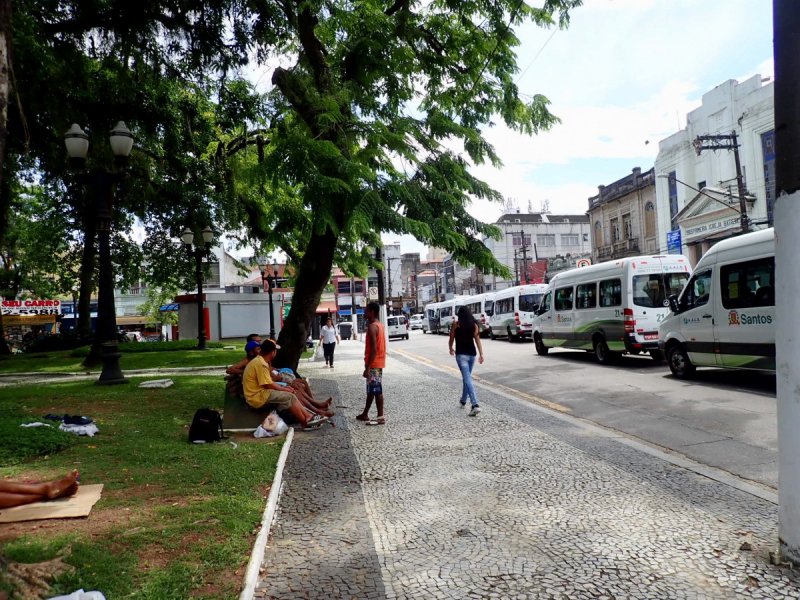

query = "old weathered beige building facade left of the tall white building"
587;167;658;263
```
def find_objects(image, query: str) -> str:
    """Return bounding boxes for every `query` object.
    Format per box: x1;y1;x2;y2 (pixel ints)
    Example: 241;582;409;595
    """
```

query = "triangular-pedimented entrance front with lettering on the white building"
676;188;755;266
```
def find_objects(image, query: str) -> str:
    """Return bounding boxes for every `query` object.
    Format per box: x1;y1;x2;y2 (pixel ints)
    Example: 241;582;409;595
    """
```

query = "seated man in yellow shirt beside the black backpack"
242;340;328;428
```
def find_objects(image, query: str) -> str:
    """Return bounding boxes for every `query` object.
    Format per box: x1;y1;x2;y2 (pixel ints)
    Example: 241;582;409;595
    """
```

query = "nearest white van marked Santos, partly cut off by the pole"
658;229;775;379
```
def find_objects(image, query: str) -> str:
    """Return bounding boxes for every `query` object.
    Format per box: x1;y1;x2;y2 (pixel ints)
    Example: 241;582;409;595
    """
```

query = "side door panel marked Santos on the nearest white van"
716;256;775;371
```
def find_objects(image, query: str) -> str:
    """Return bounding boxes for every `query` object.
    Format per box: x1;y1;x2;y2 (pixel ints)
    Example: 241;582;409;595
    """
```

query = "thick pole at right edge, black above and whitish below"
772;0;800;565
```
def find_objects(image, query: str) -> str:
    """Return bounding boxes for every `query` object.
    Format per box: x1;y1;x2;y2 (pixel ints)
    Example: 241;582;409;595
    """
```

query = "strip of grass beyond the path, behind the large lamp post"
0;346;313;373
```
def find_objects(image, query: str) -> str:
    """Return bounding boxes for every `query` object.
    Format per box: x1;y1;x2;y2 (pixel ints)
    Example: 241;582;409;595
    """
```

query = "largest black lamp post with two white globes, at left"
64;121;133;385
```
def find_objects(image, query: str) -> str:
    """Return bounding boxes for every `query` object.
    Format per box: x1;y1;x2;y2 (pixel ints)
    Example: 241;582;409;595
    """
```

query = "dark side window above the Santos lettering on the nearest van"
719;257;775;309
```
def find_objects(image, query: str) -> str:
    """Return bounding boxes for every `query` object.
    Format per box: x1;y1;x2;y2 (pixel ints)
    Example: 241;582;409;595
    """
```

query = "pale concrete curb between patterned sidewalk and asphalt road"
396;351;778;504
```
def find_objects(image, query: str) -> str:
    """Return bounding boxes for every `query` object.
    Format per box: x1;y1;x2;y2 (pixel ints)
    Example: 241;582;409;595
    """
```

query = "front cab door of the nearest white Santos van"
679;268;722;366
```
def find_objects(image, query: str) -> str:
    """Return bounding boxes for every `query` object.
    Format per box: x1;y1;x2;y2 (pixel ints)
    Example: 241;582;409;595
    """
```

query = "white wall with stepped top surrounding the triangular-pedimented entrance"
655;75;775;253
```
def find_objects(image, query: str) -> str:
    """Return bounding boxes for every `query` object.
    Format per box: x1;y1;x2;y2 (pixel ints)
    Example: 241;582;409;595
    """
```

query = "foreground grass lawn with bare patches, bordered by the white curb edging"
0;376;283;600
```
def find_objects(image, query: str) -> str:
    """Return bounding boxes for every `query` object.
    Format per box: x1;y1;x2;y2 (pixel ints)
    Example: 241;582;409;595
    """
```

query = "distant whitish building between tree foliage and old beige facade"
484;210;592;291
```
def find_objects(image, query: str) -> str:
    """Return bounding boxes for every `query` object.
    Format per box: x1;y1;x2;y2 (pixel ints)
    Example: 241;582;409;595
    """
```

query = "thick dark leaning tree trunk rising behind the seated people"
275;229;337;370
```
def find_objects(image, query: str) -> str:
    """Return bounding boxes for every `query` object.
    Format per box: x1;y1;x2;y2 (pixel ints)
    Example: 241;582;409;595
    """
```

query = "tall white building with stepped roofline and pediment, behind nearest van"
655;75;775;264
